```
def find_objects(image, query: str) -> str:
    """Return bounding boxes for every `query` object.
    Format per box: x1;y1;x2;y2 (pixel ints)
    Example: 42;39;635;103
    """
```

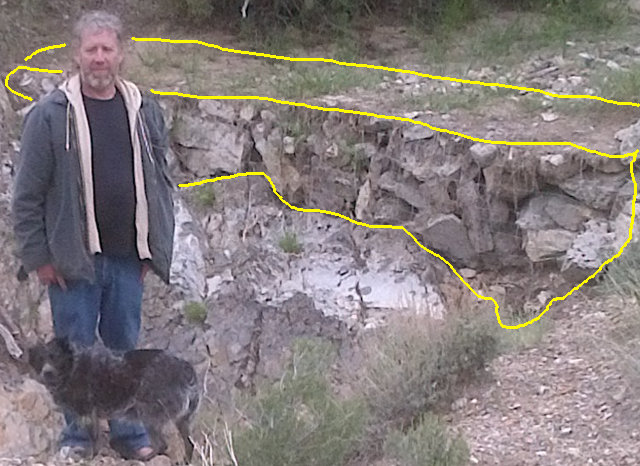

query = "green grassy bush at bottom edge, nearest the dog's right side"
228;339;366;466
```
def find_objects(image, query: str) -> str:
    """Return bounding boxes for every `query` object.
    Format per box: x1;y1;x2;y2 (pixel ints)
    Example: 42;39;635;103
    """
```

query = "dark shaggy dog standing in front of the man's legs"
29;338;201;461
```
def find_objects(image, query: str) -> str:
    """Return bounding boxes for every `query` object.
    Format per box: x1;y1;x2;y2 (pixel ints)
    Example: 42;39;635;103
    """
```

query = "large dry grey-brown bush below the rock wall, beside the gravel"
364;312;498;427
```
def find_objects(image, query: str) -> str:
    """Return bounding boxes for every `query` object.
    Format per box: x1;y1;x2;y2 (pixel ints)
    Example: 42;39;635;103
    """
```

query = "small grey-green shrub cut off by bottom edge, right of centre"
384;414;469;466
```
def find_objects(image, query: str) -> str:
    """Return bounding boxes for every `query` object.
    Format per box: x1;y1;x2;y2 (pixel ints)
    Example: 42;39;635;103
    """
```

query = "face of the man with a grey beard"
75;29;123;91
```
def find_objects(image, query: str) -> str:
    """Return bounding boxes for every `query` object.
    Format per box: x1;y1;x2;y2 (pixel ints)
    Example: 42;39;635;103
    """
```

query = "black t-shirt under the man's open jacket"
83;90;137;257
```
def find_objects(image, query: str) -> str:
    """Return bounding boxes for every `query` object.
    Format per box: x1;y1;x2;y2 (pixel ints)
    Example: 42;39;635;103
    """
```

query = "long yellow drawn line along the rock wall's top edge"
150;89;633;159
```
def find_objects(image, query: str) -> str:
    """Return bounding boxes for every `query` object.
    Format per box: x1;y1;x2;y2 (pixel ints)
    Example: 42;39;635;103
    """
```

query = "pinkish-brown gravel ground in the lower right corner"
452;296;640;466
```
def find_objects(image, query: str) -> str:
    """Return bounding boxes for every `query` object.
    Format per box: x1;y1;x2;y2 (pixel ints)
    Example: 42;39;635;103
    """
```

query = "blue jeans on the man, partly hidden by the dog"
49;255;150;451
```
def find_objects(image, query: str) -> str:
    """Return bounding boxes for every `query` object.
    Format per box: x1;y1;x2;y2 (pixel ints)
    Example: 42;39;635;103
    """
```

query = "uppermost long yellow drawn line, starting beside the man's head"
131;37;640;107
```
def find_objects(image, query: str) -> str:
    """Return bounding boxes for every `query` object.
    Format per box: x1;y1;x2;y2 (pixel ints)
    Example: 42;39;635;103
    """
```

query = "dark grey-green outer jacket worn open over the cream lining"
12;83;174;283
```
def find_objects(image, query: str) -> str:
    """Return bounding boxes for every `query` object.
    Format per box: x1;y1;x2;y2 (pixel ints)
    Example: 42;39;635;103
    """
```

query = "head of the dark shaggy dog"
28;338;74;389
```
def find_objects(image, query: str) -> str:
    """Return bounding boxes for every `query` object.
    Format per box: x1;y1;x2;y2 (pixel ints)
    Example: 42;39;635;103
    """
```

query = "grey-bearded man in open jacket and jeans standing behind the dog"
12;12;174;460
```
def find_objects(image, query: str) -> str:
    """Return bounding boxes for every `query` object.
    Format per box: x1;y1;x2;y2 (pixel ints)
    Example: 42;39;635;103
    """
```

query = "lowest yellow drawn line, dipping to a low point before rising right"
178;151;638;330
